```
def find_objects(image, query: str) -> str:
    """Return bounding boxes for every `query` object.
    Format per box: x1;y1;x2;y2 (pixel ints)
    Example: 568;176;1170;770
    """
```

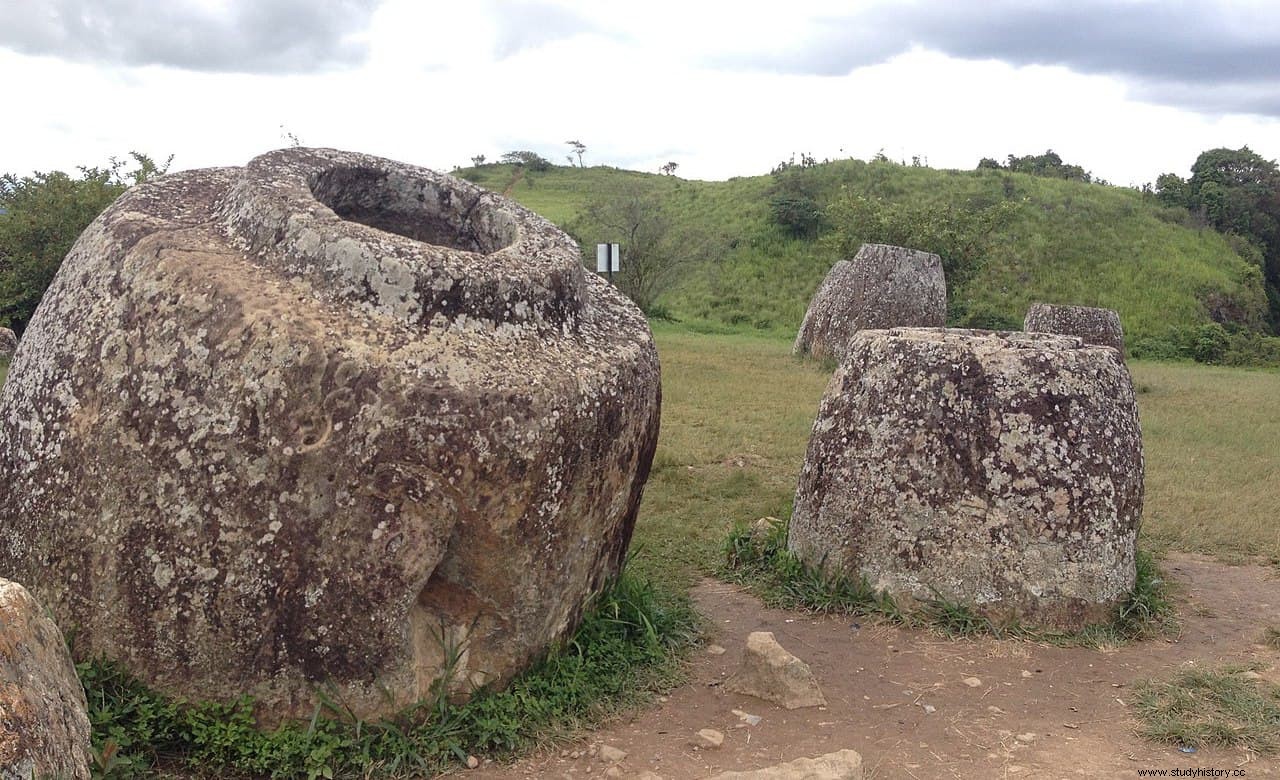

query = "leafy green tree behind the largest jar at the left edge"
0;151;173;333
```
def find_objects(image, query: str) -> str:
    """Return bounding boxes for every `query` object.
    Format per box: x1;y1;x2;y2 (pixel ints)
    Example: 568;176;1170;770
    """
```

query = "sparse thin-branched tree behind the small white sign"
570;192;689;313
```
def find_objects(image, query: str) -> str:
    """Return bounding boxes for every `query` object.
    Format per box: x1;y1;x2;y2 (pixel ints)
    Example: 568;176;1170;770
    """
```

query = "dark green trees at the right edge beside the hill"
1155;146;1280;330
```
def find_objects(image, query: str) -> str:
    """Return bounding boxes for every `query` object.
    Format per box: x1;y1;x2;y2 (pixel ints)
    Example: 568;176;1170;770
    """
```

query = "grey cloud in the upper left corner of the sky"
0;0;378;73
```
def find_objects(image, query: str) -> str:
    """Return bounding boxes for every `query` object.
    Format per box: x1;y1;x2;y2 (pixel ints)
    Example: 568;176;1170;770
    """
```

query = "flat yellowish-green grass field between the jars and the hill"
635;318;1280;584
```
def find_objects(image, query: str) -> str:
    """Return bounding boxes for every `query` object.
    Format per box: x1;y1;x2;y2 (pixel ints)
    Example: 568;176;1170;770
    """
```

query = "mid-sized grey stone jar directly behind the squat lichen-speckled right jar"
792;243;947;361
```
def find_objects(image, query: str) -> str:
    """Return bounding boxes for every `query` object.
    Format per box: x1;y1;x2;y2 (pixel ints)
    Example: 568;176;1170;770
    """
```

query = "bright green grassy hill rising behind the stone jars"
460;160;1266;345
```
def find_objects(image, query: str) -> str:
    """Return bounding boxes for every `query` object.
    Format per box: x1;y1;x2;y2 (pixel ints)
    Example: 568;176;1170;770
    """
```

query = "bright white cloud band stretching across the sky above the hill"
0;0;1280;184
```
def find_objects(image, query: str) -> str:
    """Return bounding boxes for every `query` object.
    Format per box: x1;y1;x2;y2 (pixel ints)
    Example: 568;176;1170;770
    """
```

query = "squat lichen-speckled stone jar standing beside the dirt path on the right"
787;329;1143;628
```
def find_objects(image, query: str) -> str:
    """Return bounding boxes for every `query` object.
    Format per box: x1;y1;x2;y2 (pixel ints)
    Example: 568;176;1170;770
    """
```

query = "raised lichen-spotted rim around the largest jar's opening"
216;147;585;329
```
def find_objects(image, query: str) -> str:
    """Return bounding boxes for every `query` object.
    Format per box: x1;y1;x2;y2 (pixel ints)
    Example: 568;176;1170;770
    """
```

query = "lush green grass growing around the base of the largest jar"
78;574;696;779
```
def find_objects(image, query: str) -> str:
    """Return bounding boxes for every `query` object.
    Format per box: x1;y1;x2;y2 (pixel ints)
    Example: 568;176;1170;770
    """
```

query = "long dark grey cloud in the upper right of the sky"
733;0;1280;115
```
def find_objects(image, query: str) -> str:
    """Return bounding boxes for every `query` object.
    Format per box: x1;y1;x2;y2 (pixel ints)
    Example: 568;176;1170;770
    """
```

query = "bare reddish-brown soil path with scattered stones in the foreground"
481;555;1280;780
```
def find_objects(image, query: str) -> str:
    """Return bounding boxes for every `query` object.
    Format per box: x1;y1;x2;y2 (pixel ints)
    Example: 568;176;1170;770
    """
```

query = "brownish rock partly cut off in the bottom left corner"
0;579;90;780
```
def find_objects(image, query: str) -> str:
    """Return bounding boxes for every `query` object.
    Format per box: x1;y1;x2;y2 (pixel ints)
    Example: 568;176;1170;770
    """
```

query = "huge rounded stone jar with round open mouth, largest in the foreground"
0;149;659;716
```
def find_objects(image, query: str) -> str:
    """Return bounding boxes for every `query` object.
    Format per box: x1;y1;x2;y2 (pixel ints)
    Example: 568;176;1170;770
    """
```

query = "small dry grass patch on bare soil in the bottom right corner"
1133;666;1280;753
